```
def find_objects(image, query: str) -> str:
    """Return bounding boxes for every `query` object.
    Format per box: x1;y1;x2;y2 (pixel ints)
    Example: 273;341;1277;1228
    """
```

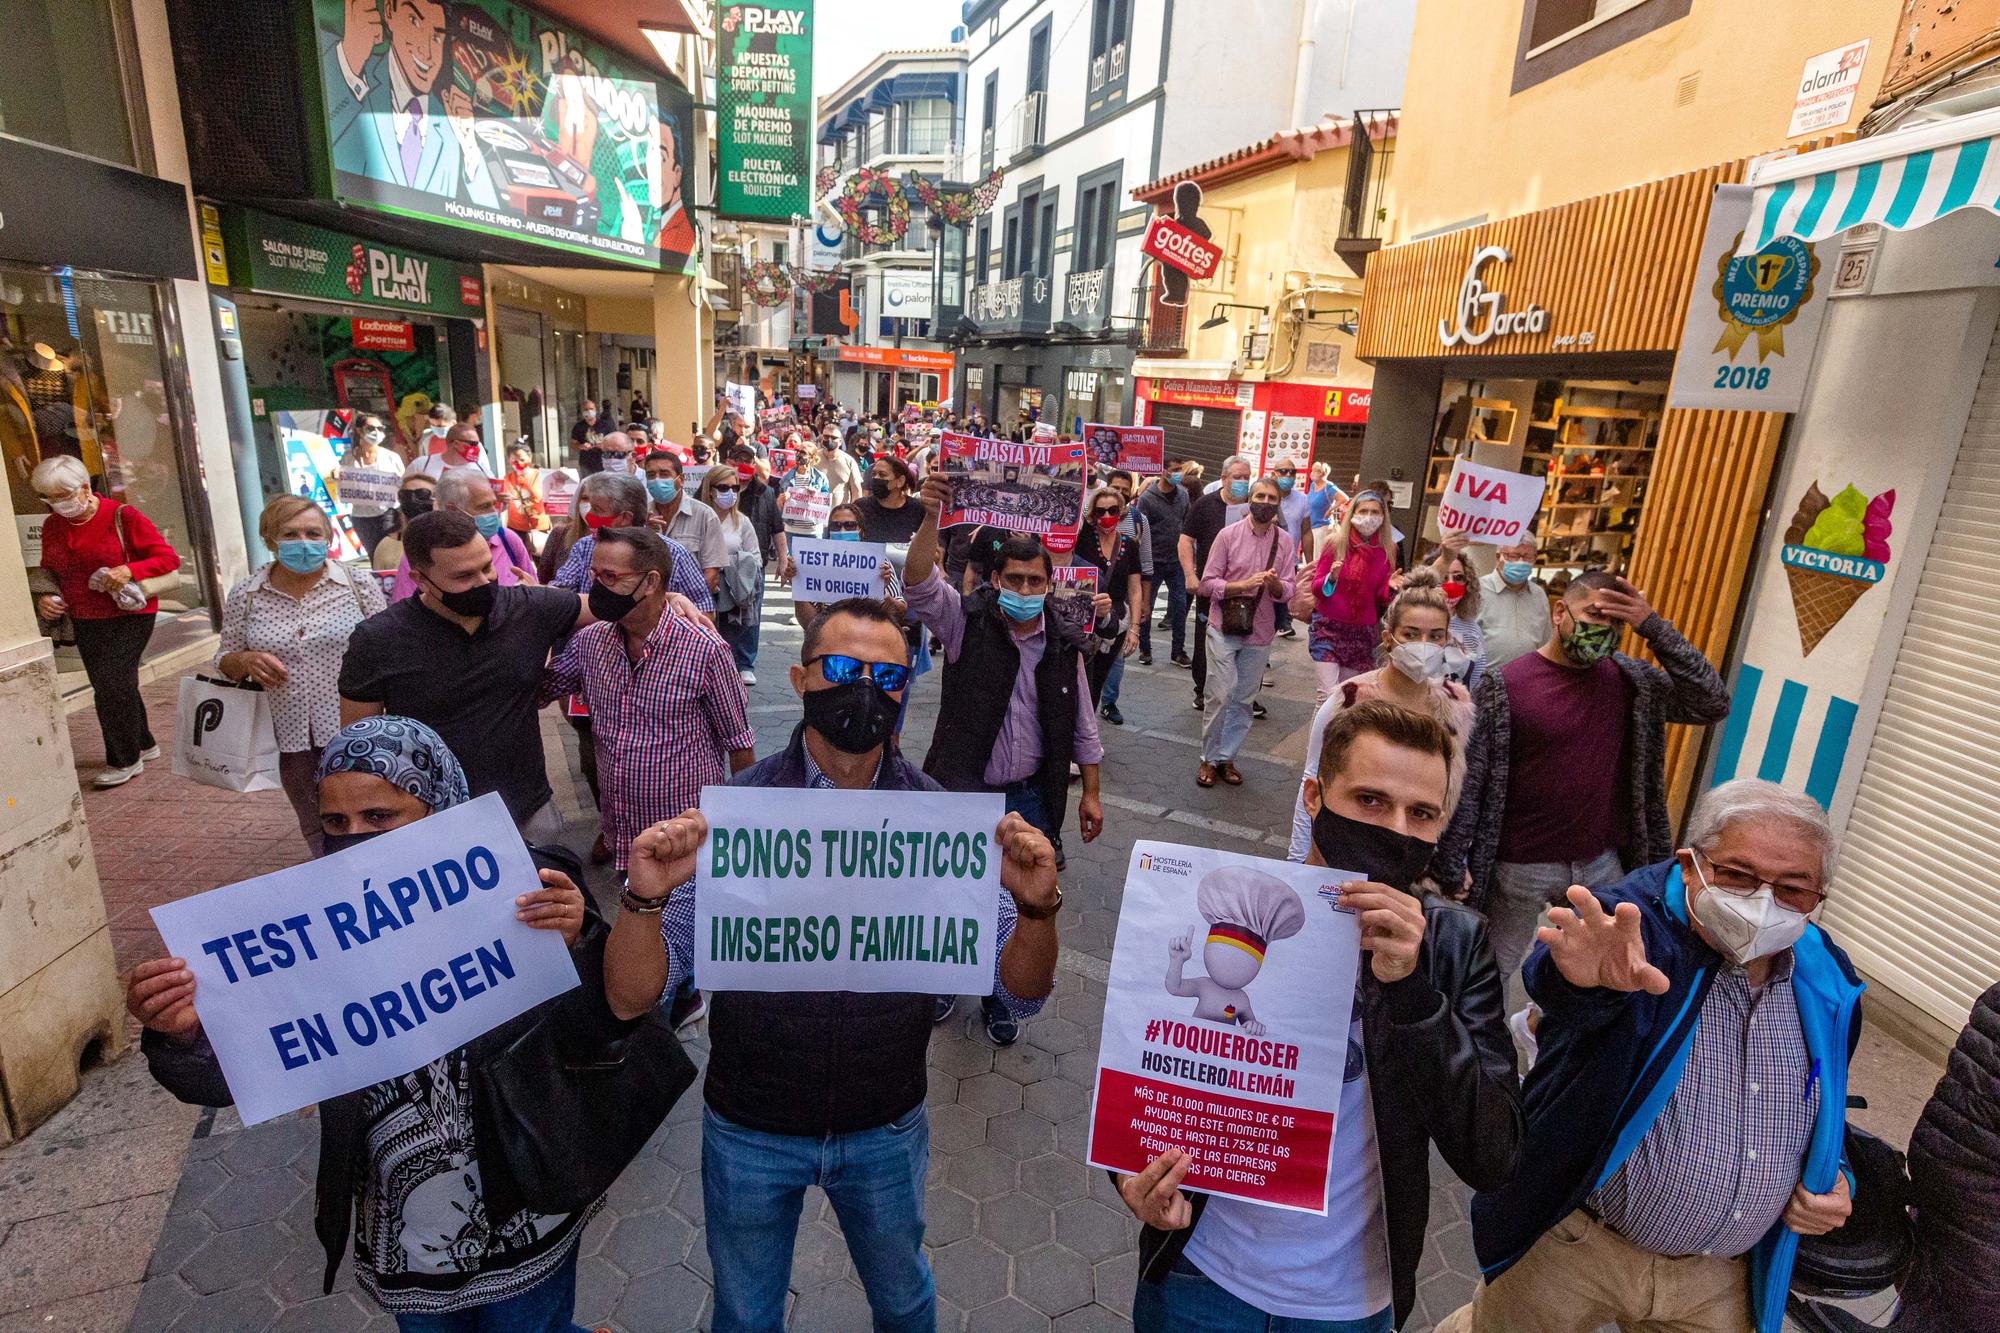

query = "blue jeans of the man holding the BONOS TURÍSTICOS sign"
702;1105;938;1333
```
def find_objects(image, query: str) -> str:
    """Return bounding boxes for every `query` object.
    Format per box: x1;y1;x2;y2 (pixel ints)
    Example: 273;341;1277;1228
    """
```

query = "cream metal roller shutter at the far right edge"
1826;324;2000;1031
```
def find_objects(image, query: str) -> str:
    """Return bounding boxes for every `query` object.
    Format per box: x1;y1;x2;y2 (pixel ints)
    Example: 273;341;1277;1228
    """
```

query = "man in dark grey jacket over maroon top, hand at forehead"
1432;570;1730;999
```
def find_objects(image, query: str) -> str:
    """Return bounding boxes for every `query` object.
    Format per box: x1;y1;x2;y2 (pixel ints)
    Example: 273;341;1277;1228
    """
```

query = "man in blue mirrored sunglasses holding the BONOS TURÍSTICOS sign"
604;598;1062;1333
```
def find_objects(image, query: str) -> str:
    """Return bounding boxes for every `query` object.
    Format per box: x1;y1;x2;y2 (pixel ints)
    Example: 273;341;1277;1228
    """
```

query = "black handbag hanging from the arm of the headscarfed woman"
472;1009;694;1213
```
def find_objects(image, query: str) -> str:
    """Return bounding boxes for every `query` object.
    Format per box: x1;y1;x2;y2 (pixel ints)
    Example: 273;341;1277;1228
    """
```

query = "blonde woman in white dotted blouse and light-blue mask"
216;494;388;857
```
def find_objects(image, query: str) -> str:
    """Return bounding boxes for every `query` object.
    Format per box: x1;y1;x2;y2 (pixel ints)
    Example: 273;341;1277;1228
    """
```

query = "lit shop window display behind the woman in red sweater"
0;264;206;614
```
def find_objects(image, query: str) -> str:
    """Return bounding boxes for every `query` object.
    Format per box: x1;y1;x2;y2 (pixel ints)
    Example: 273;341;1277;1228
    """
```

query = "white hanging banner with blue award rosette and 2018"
1666;186;1828;412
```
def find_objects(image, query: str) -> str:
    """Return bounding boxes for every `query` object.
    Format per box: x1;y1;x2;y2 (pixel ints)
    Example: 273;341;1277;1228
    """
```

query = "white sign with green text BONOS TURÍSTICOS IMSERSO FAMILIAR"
694;787;1006;995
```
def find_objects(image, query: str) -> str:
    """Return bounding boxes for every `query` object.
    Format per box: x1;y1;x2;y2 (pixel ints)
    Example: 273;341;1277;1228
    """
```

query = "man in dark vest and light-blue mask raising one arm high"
904;472;1104;1047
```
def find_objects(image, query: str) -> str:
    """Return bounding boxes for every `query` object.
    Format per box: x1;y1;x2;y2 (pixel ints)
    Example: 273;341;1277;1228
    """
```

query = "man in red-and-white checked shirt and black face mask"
540;528;756;871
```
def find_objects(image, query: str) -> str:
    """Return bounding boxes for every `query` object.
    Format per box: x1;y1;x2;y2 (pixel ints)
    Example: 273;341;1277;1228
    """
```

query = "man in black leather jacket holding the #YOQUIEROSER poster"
1118;701;1524;1333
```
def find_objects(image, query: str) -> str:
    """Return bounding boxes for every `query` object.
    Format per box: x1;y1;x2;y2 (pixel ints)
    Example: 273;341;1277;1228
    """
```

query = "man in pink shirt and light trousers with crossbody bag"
1194;476;1298;787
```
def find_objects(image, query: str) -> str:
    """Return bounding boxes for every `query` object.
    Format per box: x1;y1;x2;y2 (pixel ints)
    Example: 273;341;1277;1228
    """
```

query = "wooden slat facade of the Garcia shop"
1356;162;1784;823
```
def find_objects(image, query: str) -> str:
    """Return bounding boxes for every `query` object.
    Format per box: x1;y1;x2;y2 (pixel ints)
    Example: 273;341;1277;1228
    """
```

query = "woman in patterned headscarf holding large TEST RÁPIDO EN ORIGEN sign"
126;717;632;1333
